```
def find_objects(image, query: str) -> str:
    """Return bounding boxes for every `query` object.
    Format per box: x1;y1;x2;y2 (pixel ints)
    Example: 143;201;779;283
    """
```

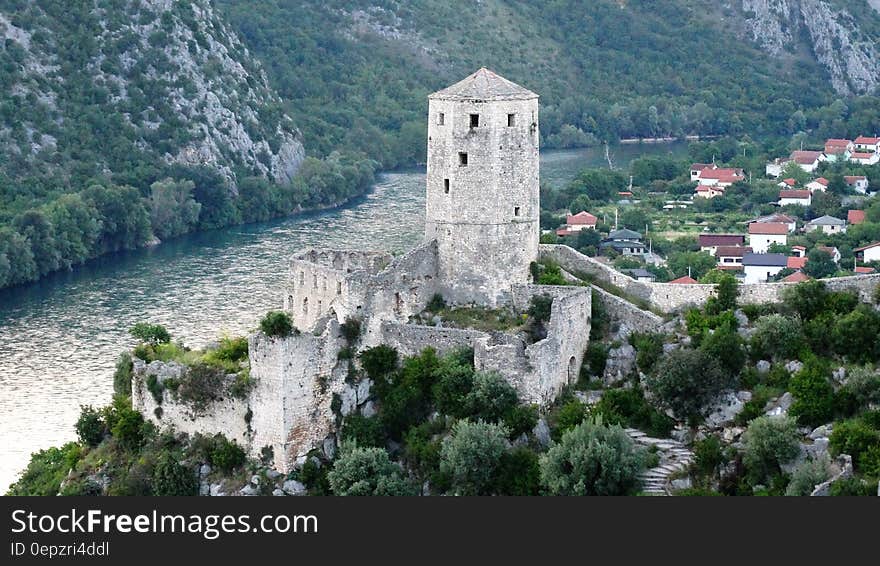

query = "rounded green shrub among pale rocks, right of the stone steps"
743;416;800;484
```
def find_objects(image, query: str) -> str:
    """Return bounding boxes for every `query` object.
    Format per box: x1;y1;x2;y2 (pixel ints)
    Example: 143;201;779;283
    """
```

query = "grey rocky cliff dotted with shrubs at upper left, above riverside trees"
0;0;304;182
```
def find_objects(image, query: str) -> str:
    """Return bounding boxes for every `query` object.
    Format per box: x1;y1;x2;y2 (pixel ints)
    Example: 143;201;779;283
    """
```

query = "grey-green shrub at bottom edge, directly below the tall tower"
440;421;507;495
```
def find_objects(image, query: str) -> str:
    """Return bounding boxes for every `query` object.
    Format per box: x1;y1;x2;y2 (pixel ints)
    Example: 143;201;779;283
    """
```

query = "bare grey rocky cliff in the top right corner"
741;0;880;94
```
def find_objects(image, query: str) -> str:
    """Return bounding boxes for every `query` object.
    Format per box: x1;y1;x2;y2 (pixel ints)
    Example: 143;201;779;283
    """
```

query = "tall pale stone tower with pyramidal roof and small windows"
425;68;540;306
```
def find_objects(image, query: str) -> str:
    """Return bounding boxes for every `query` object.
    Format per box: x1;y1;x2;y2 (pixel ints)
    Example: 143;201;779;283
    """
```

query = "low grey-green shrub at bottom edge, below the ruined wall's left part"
327;447;415;496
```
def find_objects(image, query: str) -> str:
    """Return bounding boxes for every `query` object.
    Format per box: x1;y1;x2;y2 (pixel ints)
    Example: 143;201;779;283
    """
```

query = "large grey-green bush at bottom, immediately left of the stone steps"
540;418;645;495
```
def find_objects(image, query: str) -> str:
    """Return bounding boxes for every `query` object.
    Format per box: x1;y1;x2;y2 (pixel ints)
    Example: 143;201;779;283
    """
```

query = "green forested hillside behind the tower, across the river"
217;0;878;166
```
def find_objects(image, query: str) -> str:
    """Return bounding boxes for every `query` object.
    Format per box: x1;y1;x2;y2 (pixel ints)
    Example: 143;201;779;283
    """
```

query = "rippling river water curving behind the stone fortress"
0;143;686;493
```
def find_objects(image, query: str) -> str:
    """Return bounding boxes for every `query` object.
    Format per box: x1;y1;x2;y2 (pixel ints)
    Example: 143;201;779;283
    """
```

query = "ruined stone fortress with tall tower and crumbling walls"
133;69;591;471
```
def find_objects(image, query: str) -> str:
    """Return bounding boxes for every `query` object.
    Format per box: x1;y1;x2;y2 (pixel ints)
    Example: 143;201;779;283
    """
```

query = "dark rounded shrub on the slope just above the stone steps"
648;349;735;424
